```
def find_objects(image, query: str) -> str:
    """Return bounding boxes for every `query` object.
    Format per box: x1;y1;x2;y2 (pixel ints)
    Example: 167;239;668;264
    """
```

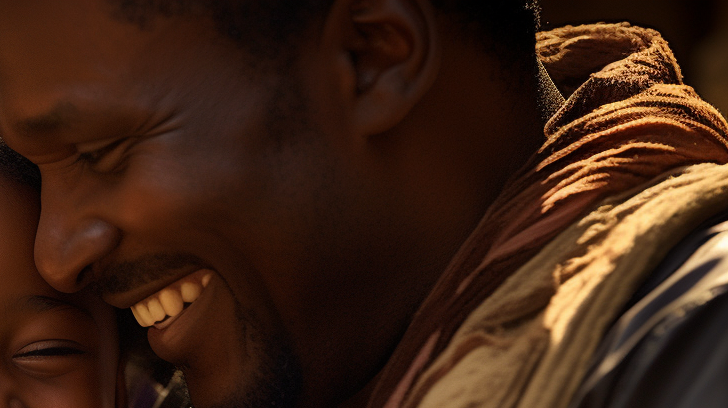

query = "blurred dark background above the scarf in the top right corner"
541;0;728;115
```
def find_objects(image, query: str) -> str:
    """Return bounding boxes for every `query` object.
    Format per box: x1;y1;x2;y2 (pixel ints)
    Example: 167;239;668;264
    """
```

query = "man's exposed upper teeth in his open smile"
131;272;212;327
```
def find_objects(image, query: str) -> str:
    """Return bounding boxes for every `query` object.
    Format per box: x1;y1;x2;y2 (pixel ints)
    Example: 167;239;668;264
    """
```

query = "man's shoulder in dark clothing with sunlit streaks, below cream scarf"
572;214;728;408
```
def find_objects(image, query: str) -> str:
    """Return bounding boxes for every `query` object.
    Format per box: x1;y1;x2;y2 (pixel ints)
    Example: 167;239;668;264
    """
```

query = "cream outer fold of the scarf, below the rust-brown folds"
412;164;728;408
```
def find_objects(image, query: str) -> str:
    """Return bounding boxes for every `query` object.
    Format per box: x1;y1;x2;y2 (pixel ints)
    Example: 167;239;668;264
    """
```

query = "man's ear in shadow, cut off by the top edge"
324;0;440;136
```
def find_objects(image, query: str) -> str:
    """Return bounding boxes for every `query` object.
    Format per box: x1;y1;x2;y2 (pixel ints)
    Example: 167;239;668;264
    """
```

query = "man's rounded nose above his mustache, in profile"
35;180;120;293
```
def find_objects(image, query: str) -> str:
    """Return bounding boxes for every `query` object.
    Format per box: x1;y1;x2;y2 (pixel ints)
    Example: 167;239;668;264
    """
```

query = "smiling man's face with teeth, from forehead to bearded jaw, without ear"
0;0;410;407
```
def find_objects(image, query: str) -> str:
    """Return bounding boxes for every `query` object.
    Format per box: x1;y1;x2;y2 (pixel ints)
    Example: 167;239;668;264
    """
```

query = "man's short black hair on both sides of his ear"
109;0;540;63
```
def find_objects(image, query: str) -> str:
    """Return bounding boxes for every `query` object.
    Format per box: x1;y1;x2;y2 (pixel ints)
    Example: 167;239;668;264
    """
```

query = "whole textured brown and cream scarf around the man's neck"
369;24;728;408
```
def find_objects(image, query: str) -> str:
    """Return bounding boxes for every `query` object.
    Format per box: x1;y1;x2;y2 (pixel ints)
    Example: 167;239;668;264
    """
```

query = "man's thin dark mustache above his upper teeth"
91;252;209;297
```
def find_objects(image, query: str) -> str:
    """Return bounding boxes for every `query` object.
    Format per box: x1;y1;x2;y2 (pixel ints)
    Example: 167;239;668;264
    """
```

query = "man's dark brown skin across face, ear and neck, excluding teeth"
0;0;542;407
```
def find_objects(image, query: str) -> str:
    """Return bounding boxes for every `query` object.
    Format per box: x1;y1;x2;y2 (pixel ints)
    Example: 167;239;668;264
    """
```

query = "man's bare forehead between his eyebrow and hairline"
0;0;222;140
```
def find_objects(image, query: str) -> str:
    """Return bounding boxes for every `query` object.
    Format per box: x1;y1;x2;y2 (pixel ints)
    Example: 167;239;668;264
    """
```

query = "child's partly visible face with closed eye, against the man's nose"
0;181;119;408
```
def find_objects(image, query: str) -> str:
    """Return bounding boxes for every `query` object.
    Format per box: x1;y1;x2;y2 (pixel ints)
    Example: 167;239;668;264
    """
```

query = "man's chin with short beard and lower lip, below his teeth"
136;274;301;408
